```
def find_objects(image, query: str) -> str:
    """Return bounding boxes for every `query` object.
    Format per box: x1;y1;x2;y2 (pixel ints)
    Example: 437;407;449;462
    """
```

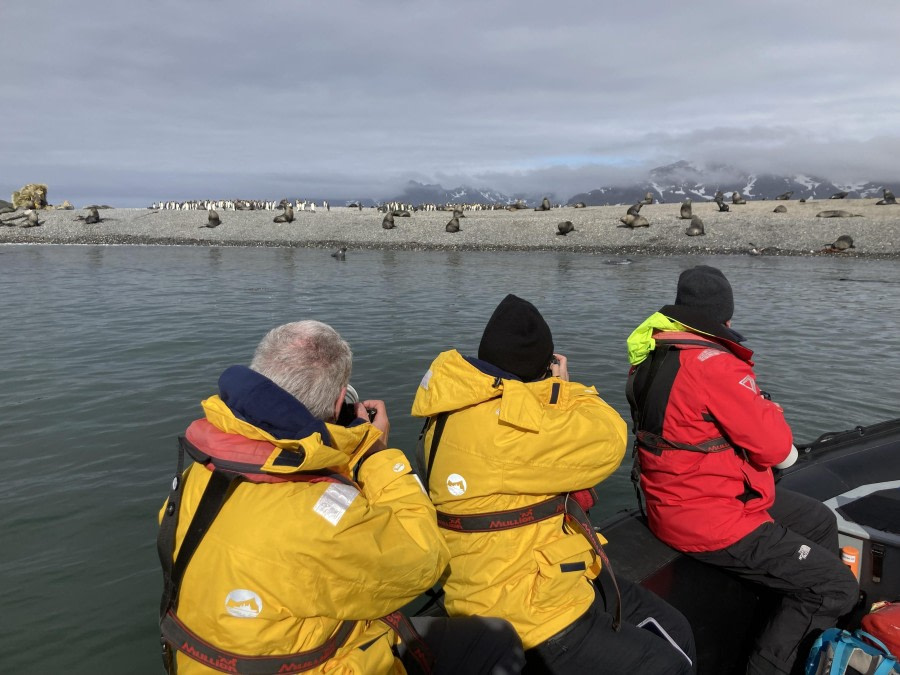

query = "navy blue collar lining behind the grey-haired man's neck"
219;366;331;445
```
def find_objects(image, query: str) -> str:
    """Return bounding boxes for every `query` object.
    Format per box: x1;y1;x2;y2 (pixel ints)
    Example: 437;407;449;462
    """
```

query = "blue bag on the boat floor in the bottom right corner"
806;628;900;675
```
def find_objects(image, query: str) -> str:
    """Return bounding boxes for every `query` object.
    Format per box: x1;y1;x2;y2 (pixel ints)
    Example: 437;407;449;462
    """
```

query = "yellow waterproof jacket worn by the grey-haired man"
160;396;449;675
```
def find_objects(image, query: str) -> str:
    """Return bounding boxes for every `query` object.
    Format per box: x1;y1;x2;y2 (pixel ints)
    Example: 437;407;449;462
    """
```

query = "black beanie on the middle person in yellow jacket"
478;294;553;382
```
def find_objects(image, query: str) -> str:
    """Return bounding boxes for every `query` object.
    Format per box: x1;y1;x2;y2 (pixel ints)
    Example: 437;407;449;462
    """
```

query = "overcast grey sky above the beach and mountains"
0;0;900;206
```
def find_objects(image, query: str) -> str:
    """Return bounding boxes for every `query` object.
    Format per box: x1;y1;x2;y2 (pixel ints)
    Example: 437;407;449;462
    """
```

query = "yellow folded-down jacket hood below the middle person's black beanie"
412;349;559;431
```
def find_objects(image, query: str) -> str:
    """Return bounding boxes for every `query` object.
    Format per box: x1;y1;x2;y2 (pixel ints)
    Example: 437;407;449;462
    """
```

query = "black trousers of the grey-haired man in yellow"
398;616;525;675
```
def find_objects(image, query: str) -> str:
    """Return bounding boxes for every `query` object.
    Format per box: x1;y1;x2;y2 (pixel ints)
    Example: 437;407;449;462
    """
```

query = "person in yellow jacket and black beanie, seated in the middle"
412;295;696;675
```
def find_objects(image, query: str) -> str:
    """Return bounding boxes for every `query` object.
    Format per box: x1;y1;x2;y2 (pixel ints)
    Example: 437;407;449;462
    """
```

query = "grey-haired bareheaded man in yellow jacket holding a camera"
158;321;524;675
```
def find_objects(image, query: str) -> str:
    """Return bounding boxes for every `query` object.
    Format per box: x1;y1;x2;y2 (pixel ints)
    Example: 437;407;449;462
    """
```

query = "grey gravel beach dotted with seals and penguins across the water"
0;199;900;258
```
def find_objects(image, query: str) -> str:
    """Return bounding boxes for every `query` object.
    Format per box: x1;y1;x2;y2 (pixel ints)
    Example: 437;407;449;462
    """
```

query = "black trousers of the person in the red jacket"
691;490;859;675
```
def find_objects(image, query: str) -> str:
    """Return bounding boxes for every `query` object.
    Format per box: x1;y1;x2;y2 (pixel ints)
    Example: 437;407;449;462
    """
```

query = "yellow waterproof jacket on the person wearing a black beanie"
412;350;627;649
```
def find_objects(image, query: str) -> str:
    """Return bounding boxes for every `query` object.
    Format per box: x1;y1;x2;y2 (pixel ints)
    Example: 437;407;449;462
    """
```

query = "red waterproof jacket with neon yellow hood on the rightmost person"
629;308;792;552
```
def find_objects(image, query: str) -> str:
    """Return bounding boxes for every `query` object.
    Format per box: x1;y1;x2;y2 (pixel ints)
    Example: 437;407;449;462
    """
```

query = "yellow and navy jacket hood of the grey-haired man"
201;366;381;473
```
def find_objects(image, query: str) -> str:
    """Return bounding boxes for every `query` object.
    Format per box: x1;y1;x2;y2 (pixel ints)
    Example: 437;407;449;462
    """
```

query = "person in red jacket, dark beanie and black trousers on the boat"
626;265;858;675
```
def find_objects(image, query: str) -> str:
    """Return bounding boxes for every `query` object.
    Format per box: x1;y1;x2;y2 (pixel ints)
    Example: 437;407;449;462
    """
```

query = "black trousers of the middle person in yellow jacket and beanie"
523;572;697;675
